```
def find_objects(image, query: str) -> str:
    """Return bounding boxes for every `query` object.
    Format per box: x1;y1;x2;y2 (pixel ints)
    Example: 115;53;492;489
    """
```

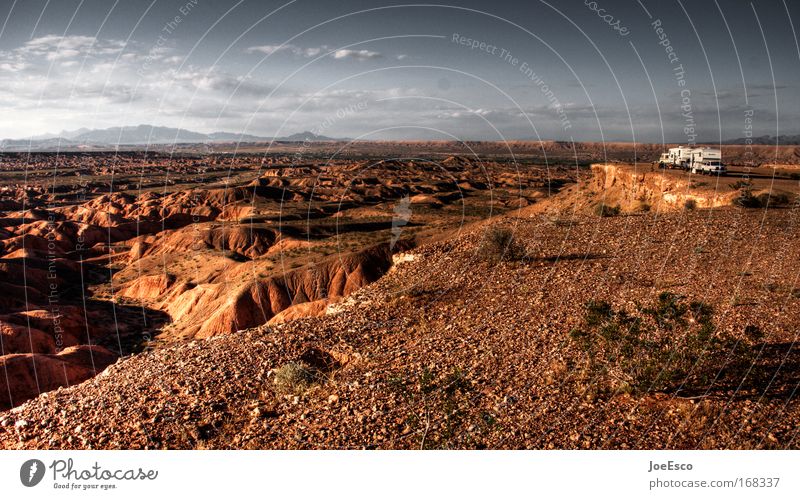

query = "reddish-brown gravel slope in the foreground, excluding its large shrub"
0;205;800;449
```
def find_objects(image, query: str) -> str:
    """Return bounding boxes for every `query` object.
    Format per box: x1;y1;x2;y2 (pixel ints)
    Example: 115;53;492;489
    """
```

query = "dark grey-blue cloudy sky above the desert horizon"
0;0;800;143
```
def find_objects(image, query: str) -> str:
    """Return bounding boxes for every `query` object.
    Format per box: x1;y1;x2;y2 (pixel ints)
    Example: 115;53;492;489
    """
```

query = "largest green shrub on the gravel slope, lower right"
570;292;761;394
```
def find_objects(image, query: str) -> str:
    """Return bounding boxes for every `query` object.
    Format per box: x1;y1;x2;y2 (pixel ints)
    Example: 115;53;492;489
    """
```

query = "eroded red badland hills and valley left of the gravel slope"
0;150;574;410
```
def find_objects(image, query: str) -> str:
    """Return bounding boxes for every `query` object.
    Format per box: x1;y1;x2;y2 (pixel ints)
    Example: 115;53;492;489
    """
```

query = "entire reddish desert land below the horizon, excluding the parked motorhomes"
0;142;800;449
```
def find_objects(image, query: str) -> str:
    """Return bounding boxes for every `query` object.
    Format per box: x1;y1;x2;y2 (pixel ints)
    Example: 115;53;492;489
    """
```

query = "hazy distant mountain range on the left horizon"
0;125;347;152
